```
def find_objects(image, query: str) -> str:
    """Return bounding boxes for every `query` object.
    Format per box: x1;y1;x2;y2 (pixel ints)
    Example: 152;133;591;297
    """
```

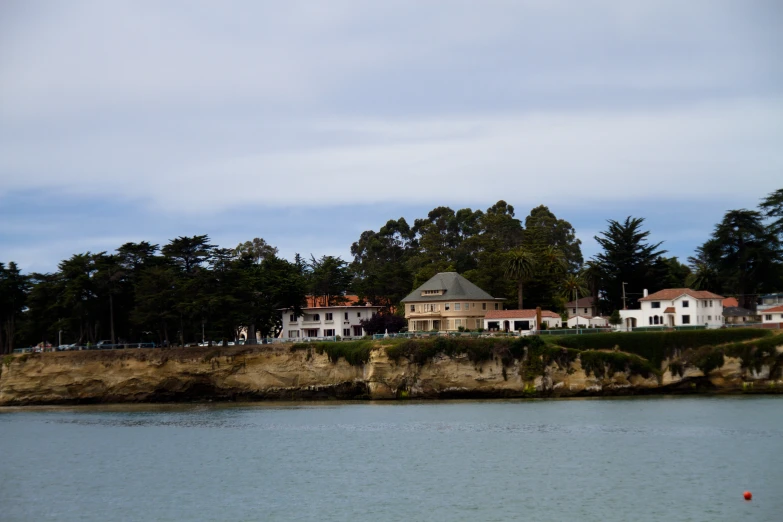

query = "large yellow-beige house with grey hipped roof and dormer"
402;272;503;332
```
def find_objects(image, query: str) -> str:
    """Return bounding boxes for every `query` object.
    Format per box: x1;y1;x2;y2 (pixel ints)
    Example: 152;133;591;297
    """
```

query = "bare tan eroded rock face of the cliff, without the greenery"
0;347;783;405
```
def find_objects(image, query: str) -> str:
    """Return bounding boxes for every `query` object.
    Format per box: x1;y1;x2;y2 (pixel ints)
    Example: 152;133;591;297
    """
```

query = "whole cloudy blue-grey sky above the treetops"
0;0;783;271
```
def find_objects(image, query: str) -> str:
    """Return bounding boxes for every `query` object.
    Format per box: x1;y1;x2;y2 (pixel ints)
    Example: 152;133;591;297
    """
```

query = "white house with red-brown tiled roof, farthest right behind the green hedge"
620;288;723;328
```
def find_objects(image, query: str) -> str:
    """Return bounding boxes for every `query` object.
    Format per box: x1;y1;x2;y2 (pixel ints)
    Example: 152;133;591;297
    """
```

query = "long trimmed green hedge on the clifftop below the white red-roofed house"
549;328;772;368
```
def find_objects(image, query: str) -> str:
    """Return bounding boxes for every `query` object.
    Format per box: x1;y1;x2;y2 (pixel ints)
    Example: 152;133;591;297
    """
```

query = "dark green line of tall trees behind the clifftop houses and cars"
0;189;783;353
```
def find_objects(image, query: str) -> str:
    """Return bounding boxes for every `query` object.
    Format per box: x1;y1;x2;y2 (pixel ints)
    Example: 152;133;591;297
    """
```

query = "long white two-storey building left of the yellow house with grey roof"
280;301;382;339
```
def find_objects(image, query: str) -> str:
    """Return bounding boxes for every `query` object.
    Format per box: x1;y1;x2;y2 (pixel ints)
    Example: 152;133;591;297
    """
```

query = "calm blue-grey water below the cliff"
0;397;783;522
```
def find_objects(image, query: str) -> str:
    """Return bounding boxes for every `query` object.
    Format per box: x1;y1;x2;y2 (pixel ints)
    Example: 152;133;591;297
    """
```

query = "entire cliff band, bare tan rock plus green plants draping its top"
0;329;783;405
